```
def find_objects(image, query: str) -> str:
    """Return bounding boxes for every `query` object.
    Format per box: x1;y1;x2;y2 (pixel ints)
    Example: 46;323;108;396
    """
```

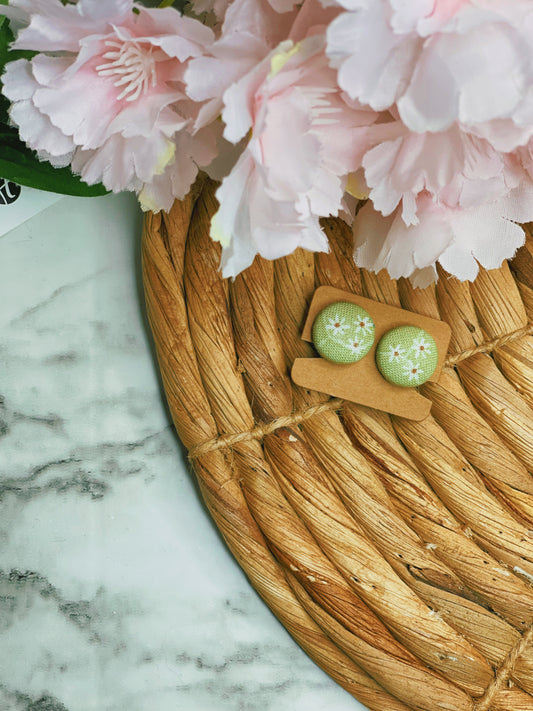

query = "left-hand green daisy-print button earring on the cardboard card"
313;302;375;363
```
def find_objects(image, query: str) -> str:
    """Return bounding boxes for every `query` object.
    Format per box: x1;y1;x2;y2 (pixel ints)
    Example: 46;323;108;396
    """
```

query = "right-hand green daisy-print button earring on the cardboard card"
376;326;438;388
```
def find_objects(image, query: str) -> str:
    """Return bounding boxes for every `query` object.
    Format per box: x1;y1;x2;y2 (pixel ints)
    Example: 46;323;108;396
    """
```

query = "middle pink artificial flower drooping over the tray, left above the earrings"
211;35;377;276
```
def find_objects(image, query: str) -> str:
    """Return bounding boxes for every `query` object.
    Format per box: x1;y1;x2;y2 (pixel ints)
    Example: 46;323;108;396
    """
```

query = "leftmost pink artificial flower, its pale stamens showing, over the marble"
3;0;215;209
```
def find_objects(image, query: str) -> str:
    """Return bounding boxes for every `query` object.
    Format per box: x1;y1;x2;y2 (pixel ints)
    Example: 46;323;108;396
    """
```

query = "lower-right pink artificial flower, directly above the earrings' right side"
353;111;533;287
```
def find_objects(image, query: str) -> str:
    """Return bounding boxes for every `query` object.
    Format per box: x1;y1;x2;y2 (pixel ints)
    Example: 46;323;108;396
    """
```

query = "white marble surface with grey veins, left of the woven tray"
0;195;363;711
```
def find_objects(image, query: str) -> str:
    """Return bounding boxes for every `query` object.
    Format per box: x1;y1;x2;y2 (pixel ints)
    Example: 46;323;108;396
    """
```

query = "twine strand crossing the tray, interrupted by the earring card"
188;324;533;461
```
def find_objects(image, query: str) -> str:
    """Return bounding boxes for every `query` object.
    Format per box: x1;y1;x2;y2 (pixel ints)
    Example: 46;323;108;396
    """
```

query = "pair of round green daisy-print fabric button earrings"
312;301;438;388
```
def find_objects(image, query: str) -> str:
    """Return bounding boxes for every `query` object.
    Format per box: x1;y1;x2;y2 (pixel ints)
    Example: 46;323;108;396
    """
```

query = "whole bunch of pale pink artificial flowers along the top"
4;0;533;286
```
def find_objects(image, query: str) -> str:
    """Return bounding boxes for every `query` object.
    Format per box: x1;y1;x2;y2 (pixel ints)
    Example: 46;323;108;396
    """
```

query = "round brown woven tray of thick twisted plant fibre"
143;182;533;711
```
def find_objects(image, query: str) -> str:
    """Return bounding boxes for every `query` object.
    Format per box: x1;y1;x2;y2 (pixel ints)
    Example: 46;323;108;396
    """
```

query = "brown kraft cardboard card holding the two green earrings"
291;286;451;421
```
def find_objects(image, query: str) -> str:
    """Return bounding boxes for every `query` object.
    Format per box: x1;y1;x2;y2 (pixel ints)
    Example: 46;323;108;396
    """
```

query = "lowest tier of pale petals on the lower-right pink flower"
354;181;533;288
